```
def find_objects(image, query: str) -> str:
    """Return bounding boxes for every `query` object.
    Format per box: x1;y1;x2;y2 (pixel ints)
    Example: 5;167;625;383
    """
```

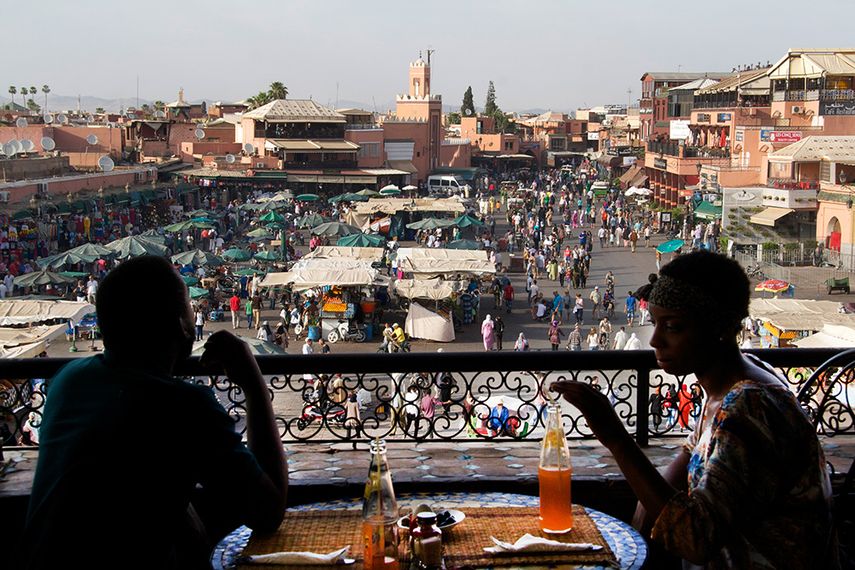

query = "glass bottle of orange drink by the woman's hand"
537;402;573;534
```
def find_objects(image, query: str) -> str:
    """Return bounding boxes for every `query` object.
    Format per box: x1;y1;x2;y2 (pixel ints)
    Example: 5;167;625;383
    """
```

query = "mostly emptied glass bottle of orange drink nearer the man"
362;439;398;570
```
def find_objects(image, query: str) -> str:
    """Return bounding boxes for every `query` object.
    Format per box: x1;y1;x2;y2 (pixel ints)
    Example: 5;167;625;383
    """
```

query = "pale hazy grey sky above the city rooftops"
5;0;855;112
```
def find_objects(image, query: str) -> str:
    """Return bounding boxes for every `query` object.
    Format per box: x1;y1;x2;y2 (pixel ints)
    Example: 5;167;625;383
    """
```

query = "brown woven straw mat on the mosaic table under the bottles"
239;505;618;570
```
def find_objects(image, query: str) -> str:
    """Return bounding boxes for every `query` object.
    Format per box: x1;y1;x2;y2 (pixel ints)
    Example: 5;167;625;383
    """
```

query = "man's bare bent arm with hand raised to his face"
202;331;288;531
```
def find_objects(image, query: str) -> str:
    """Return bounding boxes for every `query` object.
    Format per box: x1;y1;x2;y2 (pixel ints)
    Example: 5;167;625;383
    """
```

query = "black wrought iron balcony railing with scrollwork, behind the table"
0;349;855;446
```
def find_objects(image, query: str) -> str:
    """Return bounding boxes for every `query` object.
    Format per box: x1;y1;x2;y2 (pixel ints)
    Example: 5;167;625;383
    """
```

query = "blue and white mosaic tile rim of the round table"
211;493;647;570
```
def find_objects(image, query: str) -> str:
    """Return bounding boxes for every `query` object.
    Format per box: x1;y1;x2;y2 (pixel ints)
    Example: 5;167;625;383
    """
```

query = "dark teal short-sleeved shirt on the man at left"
24;352;262;568
